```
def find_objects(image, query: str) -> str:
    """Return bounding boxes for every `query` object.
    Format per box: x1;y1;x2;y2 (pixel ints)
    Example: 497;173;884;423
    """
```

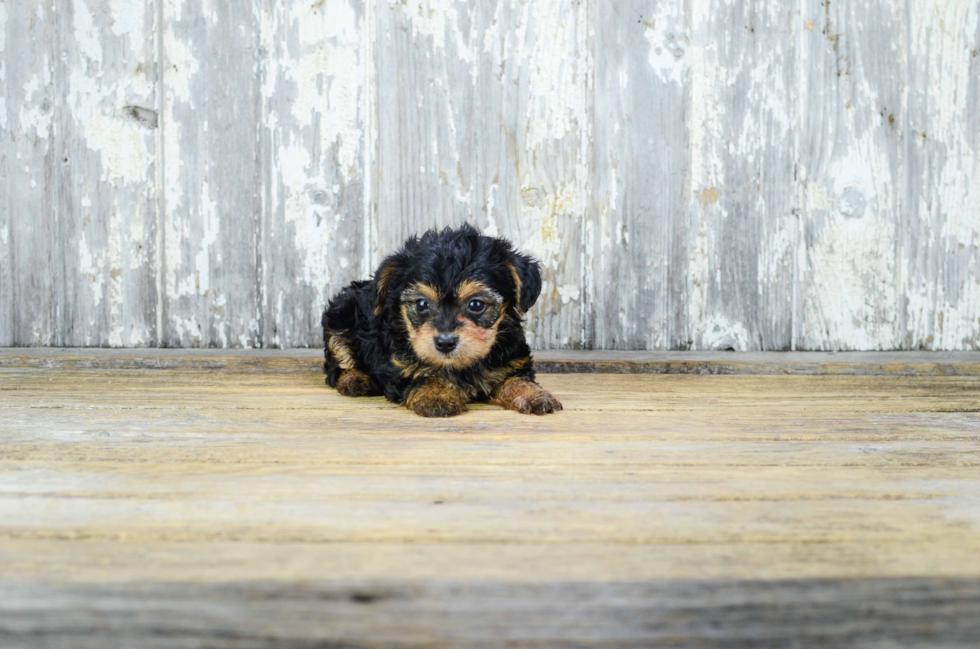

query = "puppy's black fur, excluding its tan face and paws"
322;225;560;412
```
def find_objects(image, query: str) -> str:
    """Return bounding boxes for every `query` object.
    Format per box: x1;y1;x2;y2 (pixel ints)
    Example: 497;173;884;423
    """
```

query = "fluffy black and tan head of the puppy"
375;225;541;369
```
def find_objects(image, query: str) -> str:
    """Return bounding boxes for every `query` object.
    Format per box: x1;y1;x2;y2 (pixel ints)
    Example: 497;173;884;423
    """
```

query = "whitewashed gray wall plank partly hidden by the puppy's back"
257;0;373;347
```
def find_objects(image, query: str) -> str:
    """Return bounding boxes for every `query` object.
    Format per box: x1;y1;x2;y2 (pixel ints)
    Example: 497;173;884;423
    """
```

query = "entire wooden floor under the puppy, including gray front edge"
0;356;980;649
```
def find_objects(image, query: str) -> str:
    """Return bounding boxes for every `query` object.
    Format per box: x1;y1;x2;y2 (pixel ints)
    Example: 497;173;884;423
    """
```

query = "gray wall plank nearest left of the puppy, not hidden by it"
160;0;264;347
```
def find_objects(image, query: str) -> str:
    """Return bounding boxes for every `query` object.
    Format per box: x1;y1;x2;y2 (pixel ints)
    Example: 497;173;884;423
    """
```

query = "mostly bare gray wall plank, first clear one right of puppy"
582;0;693;349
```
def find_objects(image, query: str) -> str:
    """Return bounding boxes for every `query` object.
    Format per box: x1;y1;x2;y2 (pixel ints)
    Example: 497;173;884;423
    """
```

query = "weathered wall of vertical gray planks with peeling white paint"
0;0;980;350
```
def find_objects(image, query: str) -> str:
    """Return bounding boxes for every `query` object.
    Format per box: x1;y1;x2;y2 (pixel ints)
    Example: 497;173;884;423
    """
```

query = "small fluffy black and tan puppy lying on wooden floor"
323;225;561;417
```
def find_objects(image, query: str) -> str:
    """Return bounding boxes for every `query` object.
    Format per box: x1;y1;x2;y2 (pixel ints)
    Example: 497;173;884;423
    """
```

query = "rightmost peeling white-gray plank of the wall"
900;0;980;349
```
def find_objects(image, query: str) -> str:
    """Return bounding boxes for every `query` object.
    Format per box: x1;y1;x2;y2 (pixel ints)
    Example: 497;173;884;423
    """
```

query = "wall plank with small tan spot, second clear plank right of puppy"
684;0;800;351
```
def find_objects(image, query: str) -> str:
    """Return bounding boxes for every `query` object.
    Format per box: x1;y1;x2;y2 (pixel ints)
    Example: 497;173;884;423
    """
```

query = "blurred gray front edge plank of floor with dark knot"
0;578;980;649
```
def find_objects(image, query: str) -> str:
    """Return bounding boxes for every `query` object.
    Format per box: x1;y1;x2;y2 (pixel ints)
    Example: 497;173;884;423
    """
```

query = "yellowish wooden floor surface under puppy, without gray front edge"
0;368;980;581
